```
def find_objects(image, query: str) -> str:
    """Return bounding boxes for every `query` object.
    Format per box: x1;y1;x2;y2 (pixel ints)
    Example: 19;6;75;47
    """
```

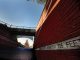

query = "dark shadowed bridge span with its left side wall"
0;24;35;47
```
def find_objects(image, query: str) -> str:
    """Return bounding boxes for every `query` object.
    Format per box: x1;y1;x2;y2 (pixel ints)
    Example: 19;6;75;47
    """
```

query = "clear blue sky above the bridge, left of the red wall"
0;0;44;27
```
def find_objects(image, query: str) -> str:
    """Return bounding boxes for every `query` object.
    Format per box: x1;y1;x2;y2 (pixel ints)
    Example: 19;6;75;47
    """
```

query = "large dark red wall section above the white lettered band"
35;0;80;47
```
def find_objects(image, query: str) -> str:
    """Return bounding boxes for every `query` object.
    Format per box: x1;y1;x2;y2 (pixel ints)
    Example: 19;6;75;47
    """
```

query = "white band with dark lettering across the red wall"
36;36;80;50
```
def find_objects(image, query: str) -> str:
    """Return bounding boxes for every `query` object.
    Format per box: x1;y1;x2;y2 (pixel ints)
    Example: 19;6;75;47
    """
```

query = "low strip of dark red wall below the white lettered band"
36;50;80;60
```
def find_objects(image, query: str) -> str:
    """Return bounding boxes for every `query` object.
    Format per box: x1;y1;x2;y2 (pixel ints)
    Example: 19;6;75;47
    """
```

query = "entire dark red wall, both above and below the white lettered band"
34;0;80;60
